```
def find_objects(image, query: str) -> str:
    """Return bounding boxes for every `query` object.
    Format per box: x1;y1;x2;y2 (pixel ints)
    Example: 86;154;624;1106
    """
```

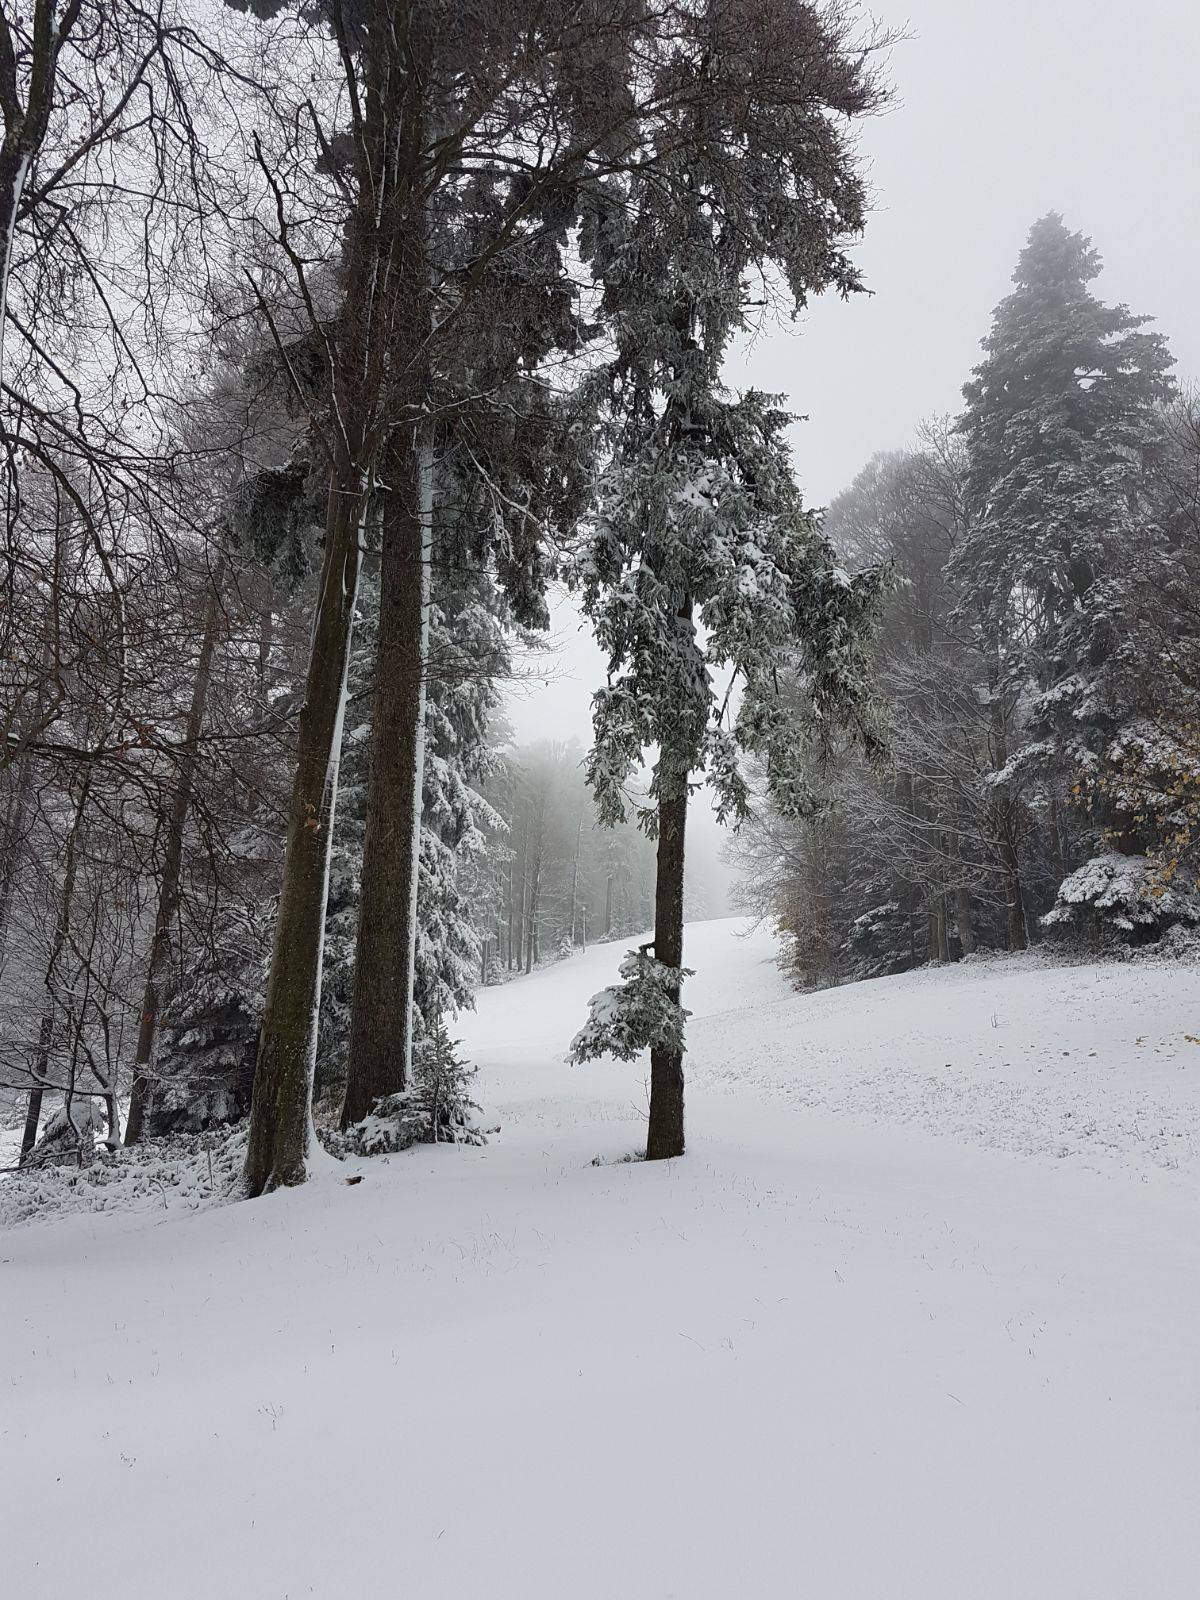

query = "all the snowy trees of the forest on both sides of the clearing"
0;0;1200;1195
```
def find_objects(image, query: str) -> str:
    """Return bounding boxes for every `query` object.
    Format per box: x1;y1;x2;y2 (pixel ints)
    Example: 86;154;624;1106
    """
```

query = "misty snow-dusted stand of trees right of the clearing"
736;214;1200;984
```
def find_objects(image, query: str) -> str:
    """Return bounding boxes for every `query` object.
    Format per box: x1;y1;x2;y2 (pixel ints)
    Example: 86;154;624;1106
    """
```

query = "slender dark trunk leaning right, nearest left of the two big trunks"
125;562;224;1144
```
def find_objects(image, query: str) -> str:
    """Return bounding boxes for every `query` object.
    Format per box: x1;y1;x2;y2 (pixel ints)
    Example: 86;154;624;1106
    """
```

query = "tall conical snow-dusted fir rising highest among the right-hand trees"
949;213;1173;946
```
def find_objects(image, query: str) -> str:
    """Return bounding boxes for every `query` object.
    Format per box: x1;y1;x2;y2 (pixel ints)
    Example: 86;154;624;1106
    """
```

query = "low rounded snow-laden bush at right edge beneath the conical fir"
1042;851;1200;944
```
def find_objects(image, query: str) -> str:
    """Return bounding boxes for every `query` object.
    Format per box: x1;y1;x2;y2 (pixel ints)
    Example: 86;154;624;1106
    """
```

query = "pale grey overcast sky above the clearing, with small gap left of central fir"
509;0;1200;742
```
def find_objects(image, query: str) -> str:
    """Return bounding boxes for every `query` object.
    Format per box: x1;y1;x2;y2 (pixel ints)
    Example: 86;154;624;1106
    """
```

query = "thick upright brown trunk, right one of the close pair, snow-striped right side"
341;422;432;1128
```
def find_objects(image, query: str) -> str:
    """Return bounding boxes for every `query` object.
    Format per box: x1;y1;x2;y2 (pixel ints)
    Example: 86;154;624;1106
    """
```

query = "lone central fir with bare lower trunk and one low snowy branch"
573;6;880;1160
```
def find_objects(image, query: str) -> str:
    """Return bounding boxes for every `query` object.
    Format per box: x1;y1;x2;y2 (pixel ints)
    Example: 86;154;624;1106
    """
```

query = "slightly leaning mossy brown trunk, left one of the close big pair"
246;470;366;1195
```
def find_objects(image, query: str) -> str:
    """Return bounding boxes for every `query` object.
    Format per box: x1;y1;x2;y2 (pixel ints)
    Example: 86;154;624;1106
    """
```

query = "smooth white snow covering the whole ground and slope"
0;922;1200;1600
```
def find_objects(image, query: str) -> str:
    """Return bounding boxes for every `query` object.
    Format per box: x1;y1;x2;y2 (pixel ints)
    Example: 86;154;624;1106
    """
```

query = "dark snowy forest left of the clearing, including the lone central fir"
0;0;886;1195
